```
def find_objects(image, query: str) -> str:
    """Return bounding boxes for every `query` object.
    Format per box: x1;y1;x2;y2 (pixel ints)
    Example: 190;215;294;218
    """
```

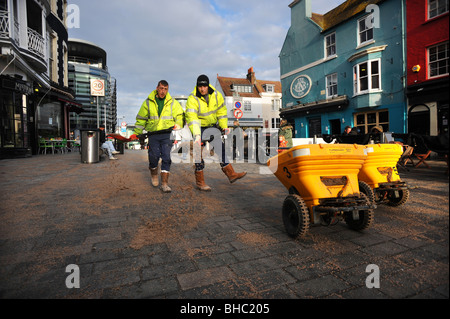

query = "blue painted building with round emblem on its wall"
280;0;407;138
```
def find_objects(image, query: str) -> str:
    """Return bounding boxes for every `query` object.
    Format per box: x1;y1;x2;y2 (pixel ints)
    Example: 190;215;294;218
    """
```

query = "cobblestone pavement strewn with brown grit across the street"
0;150;449;299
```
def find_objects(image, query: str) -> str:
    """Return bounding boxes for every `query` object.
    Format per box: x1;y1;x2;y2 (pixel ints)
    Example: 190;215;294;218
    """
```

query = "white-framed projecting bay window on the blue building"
353;59;381;95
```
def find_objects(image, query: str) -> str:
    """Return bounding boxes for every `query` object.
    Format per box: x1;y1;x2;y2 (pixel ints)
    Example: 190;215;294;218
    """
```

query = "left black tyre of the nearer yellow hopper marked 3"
282;195;310;238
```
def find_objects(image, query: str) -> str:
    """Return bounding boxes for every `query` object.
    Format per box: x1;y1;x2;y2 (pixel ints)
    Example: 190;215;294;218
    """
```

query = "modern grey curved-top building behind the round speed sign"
68;39;117;132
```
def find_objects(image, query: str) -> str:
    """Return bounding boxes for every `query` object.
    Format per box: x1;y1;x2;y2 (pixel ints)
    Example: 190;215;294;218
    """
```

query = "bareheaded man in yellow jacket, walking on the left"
130;80;184;193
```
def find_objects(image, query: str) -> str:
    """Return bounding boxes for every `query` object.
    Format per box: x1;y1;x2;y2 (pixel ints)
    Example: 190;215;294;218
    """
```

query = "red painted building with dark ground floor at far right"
406;0;449;136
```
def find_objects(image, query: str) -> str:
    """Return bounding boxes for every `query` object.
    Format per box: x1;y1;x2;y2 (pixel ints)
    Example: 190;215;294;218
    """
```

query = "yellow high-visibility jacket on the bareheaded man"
134;90;184;135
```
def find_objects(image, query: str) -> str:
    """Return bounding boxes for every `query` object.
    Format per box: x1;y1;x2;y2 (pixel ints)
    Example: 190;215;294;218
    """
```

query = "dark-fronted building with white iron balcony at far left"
0;0;77;158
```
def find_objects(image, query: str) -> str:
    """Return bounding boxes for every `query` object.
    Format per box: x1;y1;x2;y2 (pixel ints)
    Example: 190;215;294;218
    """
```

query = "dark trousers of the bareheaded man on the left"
148;133;173;172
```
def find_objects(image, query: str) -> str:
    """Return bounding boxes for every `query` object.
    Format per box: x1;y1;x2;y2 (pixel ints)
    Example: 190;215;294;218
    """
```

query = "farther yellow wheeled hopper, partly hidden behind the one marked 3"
358;144;409;206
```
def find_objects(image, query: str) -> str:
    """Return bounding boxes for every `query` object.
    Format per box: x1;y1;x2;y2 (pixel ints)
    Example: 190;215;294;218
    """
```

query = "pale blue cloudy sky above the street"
68;0;344;125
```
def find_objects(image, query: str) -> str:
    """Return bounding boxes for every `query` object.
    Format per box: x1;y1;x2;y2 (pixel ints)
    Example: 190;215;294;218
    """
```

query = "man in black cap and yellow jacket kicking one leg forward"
186;75;247;192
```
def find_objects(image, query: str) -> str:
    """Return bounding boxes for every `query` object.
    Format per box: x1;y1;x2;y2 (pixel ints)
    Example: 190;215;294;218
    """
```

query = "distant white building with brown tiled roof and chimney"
216;68;282;129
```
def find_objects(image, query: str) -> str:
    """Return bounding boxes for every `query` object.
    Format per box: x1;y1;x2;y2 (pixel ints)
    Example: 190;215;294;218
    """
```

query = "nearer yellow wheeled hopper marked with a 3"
267;144;375;237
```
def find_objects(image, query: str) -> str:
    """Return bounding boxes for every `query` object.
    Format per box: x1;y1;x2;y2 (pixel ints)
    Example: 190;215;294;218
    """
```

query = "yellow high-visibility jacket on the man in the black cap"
186;85;228;137
